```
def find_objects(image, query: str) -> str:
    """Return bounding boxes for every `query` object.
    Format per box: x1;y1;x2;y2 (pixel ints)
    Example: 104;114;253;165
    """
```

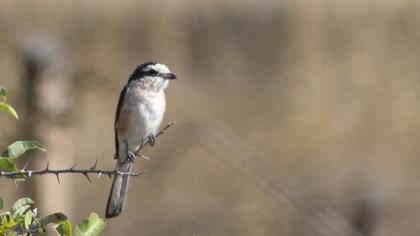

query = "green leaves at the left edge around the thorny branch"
0;87;105;236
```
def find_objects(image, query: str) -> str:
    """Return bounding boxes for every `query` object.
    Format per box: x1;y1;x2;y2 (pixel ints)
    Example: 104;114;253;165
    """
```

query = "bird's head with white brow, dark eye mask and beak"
128;61;177;91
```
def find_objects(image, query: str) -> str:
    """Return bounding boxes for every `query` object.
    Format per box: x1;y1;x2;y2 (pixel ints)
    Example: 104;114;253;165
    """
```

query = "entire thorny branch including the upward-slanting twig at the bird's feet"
0;121;175;183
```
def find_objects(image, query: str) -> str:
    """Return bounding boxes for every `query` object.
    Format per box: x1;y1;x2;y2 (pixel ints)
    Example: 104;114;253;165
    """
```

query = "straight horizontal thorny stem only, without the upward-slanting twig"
0;161;144;183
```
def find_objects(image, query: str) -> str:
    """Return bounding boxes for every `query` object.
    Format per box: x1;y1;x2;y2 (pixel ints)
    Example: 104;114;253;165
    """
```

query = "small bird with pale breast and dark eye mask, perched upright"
105;61;177;218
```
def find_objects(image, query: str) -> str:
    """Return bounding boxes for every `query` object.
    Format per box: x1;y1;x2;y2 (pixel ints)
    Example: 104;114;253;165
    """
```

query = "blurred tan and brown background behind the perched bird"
0;0;420;236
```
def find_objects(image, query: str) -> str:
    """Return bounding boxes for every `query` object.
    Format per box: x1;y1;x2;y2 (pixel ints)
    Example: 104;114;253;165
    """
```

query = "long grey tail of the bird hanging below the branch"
105;161;131;218
